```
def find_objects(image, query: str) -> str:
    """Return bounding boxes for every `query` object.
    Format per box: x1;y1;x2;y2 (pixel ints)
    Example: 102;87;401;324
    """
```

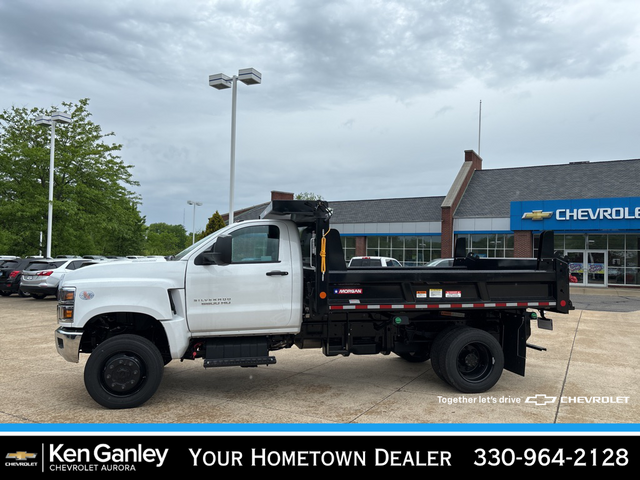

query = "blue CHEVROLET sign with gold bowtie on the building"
511;197;640;231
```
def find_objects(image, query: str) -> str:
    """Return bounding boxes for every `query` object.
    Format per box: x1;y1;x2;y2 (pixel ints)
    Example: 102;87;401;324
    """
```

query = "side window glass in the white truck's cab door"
231;225;280;263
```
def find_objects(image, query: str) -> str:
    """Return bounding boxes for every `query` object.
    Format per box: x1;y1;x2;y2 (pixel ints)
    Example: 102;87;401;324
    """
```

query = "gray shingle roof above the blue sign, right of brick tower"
455;159;640;218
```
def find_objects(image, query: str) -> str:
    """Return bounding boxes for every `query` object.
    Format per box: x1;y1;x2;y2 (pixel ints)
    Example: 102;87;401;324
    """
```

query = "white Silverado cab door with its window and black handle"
186;224;297;335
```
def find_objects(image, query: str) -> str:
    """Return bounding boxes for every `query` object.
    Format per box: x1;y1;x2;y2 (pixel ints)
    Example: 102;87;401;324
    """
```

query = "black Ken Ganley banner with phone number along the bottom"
0;433;638;478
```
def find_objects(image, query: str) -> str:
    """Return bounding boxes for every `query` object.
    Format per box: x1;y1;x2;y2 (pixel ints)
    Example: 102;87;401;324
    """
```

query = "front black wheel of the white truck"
84;335;164;409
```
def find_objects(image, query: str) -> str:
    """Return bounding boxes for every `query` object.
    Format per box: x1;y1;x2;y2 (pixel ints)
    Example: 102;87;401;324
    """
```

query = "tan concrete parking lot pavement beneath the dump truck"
0;288;640;426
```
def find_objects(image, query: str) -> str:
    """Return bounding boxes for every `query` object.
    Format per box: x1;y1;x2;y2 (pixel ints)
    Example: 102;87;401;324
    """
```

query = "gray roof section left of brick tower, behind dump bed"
329;196;444;224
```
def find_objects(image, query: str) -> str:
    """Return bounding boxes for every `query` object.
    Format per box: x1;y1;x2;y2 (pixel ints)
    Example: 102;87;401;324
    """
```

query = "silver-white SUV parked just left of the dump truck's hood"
20;258;98;300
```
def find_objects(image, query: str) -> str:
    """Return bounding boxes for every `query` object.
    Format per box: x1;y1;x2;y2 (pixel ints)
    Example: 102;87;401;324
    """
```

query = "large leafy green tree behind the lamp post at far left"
0;99;145;255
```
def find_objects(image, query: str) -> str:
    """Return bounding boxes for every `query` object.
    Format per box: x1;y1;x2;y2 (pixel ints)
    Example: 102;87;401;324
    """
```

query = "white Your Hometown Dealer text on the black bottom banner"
189;448;451;467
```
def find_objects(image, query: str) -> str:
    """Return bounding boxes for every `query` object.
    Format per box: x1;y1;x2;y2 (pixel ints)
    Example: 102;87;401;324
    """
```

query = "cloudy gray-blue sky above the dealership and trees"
0;0;640;231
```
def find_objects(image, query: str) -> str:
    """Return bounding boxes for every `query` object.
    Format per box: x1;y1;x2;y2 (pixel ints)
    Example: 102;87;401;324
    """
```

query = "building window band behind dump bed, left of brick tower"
367;235;442;267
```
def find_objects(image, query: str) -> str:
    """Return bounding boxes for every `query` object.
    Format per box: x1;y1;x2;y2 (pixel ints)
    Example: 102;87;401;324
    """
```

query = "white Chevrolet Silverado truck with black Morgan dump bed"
55;200;572;408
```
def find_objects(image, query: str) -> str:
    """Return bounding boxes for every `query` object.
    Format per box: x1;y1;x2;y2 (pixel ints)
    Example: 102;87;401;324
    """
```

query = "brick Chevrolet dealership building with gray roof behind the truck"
230;150;640;287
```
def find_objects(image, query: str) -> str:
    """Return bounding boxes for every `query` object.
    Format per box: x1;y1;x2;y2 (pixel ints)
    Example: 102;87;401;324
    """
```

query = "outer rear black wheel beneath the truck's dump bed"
439;327;504;393
